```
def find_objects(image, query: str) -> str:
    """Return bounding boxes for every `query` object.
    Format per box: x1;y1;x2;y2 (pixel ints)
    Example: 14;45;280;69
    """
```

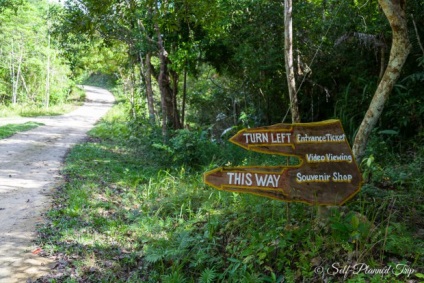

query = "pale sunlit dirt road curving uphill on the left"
0;86;114;283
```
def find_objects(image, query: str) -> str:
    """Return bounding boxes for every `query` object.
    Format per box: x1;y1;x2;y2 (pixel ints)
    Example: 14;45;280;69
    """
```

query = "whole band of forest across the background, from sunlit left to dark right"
0;0;424;145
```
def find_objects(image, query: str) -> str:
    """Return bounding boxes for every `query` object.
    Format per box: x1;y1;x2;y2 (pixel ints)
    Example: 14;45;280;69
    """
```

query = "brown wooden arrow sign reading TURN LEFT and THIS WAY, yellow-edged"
204;120;362;205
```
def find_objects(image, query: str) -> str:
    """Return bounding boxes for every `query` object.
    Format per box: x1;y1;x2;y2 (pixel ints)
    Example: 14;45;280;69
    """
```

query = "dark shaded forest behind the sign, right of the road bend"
56;0;423;144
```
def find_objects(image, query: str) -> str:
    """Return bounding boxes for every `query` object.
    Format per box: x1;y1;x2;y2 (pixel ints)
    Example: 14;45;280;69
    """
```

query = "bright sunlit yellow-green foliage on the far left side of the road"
0;1;73;108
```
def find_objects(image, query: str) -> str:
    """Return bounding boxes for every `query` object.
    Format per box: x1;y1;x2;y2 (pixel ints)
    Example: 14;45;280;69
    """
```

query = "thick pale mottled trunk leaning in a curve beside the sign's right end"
352;0;411;163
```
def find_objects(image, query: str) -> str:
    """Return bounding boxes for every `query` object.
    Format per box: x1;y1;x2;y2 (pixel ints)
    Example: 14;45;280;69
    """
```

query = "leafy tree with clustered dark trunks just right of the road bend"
61;0;219;135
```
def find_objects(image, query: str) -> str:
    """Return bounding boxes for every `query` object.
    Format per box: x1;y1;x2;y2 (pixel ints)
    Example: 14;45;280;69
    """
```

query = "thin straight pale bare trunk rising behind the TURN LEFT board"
284;0;300;123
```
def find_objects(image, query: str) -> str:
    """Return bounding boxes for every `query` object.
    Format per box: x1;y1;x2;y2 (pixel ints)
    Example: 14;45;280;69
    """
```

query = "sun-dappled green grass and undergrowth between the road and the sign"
37;98;424;283
